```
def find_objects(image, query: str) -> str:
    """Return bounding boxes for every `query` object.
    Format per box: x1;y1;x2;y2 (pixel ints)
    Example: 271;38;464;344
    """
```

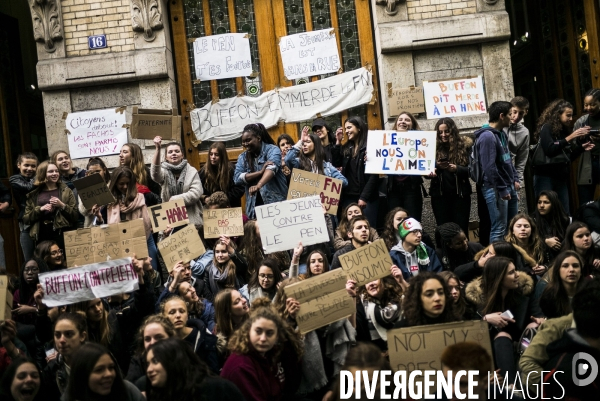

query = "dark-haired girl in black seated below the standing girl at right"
531;191;570;260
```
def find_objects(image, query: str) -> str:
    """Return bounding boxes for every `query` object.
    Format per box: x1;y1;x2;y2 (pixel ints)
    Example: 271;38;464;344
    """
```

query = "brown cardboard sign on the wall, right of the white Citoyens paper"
131;106;181;141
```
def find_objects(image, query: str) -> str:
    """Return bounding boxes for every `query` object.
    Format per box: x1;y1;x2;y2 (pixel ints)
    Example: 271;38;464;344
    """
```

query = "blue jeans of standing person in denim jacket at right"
481;185;519;244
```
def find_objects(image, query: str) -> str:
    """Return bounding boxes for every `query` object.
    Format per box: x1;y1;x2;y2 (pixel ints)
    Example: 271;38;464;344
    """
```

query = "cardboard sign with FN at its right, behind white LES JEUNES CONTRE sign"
287;168;342;215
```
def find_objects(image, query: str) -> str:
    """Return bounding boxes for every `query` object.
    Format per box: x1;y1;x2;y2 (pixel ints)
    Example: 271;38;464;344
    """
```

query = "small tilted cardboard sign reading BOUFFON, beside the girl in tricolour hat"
339;239;394;286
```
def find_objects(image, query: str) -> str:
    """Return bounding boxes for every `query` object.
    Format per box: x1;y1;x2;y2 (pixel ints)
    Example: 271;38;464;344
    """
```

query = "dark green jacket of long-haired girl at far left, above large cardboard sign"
23;182;79;241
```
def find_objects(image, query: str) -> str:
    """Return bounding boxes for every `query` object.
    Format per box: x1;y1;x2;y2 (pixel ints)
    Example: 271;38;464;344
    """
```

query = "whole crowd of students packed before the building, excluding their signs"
0;97;600;400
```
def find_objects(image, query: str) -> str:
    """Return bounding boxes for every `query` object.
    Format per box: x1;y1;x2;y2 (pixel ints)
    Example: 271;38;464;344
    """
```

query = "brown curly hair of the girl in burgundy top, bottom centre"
227;298;304;365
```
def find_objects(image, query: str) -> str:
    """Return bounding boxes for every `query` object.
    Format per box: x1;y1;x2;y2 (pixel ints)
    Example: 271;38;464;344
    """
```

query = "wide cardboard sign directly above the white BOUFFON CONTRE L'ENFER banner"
63;219;148;267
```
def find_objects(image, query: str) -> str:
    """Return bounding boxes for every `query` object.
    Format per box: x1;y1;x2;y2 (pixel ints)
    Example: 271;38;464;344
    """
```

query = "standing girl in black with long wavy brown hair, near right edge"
533;99;594;212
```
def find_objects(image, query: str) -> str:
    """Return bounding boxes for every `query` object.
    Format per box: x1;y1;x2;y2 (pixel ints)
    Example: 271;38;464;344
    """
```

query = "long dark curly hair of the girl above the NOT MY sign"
402;272;454;326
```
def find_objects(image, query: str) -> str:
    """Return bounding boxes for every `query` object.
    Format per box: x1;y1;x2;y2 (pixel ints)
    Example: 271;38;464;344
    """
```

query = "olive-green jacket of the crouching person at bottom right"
519;313;575;384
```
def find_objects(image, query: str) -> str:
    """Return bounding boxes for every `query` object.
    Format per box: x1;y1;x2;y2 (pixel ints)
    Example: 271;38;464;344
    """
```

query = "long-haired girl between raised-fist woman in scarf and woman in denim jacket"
200;142;244;207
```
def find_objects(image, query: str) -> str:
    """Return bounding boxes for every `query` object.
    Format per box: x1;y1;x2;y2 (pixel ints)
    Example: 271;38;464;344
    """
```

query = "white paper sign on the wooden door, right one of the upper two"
279;28;341;80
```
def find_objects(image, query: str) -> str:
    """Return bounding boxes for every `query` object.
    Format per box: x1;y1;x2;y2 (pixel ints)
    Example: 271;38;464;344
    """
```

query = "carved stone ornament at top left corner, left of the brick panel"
28;0;63;53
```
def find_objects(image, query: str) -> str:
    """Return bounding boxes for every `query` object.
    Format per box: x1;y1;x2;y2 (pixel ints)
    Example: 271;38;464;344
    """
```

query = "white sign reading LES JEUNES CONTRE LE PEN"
256;196;329;254
